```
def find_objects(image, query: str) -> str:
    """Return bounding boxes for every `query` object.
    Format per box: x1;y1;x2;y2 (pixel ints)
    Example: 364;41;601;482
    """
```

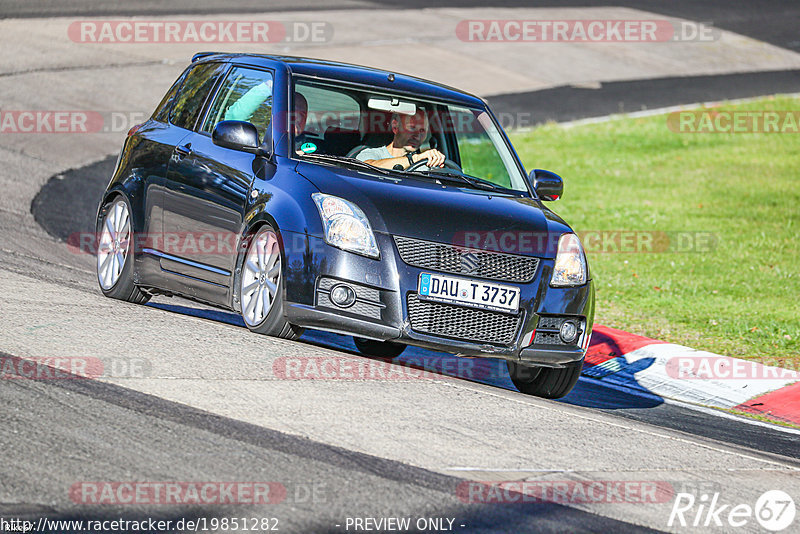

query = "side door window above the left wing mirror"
201;67;273;139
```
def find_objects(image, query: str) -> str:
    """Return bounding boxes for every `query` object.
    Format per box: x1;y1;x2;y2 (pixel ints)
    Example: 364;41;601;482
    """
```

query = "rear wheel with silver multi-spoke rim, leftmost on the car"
96;195;150;304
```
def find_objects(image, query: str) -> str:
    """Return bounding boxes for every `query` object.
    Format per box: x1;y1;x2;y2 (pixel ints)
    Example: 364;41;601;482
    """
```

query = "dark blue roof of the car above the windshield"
192;52;486;107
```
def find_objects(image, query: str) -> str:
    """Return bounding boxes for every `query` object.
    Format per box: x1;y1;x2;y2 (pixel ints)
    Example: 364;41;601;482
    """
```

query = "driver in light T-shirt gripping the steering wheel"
356;108;445;169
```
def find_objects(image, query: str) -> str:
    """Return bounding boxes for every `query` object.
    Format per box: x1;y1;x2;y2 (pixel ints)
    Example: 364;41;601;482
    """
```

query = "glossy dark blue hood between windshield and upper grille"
296;162;572;257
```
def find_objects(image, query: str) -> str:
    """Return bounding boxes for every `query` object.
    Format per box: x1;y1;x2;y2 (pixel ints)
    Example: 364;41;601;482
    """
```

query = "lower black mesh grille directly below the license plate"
408;293;522;346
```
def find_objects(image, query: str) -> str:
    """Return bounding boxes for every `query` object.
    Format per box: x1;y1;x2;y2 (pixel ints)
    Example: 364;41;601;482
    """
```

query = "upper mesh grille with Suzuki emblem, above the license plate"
394;236;539;283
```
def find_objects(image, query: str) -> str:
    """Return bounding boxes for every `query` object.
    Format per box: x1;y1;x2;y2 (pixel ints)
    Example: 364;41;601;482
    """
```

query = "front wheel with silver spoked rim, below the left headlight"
238;225;303;339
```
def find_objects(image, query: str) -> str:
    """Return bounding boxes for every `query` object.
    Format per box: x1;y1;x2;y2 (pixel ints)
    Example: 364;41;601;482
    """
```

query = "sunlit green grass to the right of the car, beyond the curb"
511;98;800;369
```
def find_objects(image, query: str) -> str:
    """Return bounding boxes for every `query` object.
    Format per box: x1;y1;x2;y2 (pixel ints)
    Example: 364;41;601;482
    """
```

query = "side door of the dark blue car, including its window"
162;66;273;304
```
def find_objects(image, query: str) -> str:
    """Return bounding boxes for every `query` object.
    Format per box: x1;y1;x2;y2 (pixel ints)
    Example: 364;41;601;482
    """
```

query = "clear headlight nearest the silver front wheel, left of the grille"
311;193;380;258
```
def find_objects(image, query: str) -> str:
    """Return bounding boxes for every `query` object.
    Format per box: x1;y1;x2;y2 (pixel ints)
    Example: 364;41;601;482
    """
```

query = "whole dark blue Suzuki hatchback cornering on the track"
97;53;594;397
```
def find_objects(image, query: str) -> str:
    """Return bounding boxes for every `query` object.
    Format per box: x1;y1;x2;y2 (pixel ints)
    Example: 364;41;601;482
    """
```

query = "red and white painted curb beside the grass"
583;324;800;424
